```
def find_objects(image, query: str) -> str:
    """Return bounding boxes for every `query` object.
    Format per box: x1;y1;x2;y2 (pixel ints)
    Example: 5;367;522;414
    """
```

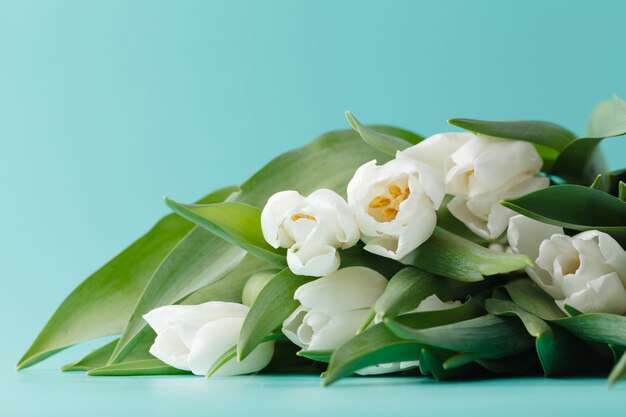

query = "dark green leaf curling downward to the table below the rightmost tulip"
485;298;591;377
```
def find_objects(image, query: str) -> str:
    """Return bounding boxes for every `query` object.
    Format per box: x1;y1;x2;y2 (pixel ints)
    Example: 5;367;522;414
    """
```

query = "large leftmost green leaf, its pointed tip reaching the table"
17;187;236;369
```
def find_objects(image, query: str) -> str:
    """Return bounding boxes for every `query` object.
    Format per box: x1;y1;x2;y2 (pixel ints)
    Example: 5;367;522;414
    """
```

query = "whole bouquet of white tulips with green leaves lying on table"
18;97;626;384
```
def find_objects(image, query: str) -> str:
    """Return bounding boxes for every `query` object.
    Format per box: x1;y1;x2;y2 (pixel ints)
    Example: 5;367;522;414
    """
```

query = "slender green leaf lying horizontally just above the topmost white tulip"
448;119;576;151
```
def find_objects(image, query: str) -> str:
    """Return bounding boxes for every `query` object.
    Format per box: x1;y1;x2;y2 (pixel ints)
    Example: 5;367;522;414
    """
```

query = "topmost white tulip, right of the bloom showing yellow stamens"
397;132;549;240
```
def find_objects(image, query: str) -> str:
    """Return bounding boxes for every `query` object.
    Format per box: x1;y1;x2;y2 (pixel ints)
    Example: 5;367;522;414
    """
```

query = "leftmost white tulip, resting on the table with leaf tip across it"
143;301;274;376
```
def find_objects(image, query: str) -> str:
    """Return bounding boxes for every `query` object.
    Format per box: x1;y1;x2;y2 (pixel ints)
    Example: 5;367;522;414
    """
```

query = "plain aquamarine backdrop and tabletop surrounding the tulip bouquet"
0;0;626;416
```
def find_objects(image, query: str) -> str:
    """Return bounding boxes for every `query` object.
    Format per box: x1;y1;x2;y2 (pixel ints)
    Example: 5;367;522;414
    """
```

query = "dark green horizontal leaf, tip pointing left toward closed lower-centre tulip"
385;314;534;358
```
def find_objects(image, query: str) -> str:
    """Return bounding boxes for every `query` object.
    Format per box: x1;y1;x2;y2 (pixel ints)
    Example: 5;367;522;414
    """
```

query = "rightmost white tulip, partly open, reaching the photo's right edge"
508;215;626;315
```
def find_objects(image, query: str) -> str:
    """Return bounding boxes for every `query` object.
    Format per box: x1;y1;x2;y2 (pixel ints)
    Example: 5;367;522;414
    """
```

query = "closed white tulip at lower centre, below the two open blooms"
282;266;387;351
